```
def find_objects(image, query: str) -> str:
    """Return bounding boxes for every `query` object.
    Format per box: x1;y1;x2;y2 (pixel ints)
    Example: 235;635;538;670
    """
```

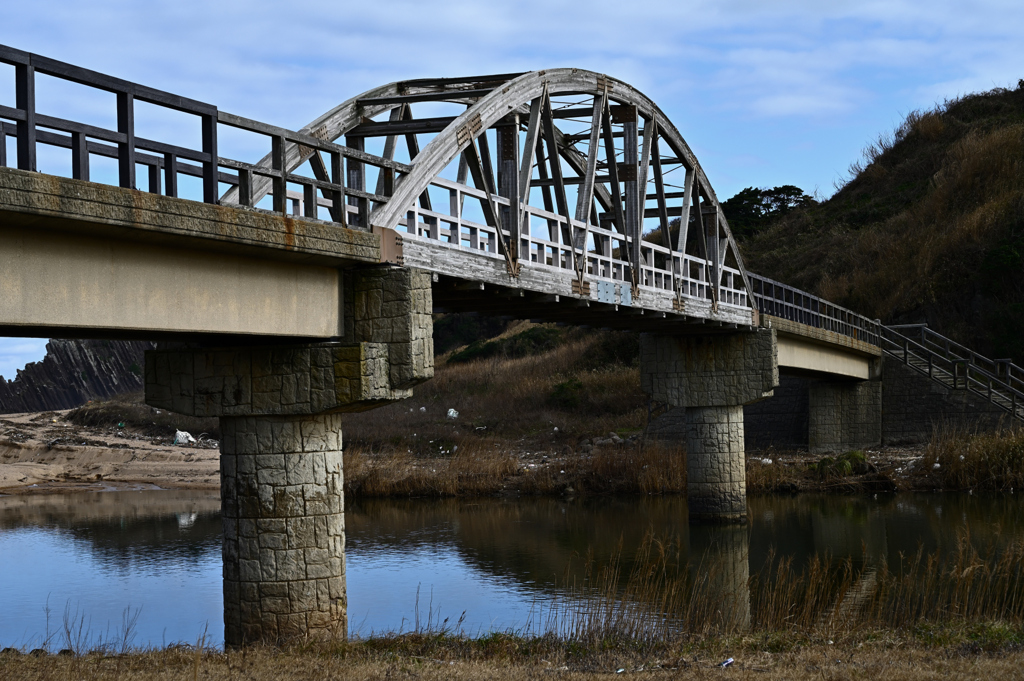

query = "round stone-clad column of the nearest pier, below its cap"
220;415;347;646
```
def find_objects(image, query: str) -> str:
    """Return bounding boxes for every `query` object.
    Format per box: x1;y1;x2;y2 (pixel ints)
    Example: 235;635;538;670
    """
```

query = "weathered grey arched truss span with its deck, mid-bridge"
228;69;756;329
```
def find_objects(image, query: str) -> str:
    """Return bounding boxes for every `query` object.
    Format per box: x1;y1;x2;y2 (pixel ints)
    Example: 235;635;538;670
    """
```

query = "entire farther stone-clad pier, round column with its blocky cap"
640;329;778;522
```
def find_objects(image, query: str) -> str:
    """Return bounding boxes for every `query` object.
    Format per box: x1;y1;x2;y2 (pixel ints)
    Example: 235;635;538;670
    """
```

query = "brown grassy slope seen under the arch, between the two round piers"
344;336;647;454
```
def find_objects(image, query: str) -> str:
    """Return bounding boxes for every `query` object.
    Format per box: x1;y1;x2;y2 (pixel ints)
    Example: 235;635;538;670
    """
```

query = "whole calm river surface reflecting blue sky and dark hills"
6;492;1024;647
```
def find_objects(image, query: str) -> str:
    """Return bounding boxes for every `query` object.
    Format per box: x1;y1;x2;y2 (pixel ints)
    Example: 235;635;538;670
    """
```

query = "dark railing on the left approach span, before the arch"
0;45;399;229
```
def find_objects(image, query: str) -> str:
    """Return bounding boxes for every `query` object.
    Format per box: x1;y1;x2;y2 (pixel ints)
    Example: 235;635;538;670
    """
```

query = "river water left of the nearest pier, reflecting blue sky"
0;491;223;647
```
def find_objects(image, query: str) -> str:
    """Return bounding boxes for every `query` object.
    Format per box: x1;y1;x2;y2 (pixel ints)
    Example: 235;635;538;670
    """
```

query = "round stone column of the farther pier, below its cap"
686;406;746;522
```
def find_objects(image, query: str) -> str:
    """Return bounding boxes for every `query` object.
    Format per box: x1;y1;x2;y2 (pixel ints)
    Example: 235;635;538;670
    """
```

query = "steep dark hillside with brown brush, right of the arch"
741;81;1024;363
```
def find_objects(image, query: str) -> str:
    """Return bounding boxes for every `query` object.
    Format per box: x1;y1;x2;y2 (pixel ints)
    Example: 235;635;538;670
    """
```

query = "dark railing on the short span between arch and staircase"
748;272;883;345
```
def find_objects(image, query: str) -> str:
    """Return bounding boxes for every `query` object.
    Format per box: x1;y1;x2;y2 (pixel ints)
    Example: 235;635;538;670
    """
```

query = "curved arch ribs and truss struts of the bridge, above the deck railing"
223;69;752;303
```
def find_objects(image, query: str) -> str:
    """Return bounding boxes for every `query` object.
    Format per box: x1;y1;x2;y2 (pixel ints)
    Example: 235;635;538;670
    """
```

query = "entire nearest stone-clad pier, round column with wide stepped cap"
145;267;433;647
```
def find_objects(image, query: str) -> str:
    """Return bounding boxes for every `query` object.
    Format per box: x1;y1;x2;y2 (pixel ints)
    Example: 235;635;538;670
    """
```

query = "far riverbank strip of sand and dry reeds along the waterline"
0;406;995;498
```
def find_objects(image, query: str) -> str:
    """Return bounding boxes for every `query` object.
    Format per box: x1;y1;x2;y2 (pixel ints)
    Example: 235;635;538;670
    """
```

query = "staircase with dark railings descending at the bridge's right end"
881;324;1024;421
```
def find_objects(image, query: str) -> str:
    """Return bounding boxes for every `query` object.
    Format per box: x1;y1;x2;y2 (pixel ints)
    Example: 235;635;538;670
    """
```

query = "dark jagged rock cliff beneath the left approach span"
0;339;154;414
